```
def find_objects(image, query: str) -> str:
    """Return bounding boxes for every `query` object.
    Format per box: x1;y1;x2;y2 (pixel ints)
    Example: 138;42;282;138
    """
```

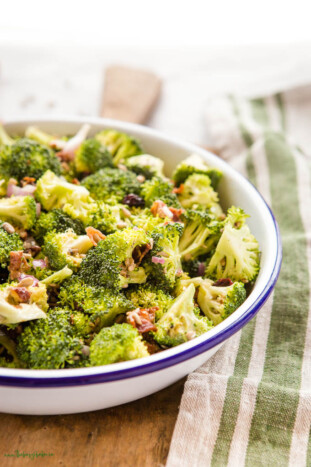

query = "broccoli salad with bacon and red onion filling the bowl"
0;125;260;369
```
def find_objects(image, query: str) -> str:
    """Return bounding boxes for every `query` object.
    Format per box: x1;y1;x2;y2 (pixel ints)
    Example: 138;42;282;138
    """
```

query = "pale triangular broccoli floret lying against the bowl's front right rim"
154;284;213;347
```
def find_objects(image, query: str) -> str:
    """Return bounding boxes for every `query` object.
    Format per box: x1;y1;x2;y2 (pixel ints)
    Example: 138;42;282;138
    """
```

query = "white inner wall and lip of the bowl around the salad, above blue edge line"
0;118;280;377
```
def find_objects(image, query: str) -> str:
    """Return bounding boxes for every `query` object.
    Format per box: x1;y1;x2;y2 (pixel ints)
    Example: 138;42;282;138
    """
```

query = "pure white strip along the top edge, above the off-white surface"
0;0;311;47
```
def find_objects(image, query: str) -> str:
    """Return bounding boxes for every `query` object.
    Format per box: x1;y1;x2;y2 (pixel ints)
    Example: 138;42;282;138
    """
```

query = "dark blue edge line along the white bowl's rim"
0;119;282;388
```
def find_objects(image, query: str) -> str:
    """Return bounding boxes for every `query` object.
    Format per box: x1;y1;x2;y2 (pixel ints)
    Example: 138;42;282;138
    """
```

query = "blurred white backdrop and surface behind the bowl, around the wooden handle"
0;0;311;144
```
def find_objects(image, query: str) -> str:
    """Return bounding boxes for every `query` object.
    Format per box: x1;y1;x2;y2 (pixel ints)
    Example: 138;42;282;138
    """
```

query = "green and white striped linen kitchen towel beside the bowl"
167;86;311;467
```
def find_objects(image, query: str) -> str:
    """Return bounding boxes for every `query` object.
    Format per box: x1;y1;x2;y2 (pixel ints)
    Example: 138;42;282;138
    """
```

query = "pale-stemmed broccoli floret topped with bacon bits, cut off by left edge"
0;282;48;325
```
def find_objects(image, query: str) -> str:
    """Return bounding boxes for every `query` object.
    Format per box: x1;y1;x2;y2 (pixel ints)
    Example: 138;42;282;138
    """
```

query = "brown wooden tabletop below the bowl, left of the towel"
0;379;185;467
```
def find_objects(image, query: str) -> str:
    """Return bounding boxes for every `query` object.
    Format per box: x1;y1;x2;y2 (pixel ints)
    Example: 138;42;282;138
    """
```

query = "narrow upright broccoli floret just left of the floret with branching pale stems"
147;222;183;290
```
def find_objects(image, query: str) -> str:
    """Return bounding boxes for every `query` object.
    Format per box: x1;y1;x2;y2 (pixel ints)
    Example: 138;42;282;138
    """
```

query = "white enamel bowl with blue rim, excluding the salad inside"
0;117;282;415
